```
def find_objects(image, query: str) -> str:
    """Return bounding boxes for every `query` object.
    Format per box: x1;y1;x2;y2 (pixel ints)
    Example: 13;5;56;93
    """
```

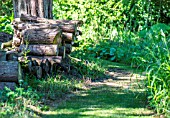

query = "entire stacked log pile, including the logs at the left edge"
0;14;83;89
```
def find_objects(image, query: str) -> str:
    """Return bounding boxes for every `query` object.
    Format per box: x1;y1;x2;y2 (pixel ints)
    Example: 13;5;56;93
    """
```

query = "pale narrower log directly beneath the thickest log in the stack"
19;44;59;56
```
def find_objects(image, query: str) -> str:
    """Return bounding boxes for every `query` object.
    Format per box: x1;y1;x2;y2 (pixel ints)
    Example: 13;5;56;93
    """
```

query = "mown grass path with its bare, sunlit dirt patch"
42;61;154;118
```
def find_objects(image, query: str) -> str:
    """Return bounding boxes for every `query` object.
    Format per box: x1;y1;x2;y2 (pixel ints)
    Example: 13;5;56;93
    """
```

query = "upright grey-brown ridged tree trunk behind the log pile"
13;0;53;19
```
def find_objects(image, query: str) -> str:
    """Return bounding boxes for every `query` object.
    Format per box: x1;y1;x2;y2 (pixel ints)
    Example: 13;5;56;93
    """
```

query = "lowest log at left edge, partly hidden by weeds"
0;82;16;90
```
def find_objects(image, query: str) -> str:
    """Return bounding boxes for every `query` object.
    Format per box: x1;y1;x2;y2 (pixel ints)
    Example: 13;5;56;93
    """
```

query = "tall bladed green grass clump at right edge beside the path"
134;23;170;114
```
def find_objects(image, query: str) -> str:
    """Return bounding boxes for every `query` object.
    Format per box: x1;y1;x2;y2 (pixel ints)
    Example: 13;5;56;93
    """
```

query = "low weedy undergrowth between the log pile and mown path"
0;75;82;117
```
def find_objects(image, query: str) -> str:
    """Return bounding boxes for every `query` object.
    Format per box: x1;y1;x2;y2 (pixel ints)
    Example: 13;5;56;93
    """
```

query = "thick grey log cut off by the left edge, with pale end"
0;61;22;82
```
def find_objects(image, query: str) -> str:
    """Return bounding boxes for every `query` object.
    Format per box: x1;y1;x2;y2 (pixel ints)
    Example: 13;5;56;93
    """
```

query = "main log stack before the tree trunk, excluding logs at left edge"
12;14;83;78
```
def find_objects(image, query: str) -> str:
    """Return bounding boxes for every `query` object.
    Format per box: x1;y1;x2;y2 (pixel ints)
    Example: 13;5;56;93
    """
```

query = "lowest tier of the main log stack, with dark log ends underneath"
18;56;62;78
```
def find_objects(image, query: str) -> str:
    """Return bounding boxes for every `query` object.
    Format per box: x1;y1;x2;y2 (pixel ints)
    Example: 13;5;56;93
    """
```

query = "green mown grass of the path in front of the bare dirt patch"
42;85;153;118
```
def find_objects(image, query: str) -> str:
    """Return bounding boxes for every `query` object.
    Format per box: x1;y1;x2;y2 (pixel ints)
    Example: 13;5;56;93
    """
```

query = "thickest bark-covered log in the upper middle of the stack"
23;27;61;44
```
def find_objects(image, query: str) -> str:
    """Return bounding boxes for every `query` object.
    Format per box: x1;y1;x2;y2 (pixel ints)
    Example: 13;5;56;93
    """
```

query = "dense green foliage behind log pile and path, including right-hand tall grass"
0;0;170;116
